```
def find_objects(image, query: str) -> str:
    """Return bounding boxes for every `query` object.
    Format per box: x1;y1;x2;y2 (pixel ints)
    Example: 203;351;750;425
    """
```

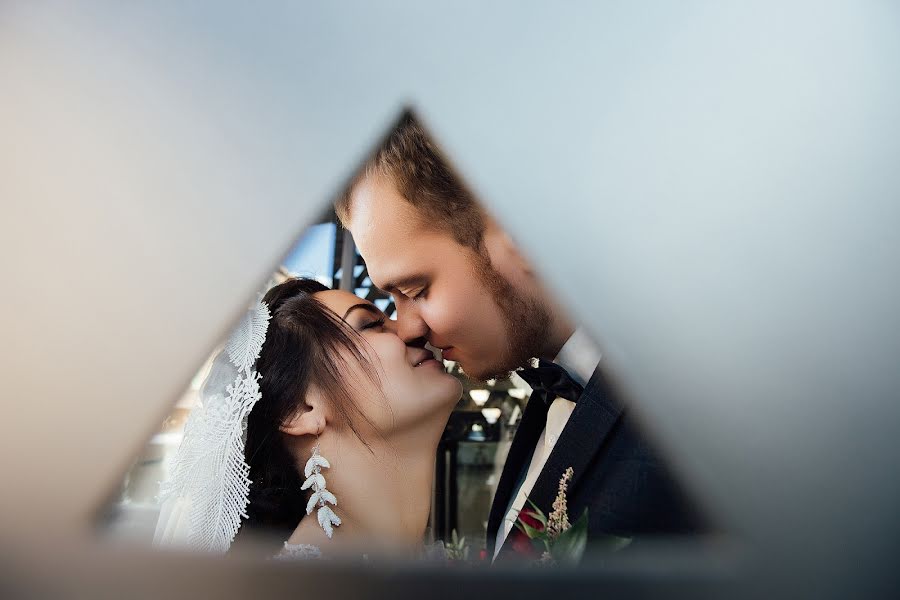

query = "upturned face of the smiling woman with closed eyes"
313;290;462;435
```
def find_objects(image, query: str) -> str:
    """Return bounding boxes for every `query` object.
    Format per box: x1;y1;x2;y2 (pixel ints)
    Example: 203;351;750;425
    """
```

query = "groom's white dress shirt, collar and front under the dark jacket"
494;328;600;558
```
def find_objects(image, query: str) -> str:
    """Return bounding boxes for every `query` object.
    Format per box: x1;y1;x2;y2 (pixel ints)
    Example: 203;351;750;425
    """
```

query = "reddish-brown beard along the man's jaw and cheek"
466;256;550;381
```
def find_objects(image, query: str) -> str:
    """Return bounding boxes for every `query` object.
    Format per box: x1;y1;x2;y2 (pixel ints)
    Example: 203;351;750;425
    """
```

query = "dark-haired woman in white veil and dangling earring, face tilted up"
155;279;462;558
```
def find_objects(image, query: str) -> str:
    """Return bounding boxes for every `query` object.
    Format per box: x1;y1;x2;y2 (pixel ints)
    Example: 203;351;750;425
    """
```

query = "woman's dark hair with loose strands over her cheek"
241;279;378;534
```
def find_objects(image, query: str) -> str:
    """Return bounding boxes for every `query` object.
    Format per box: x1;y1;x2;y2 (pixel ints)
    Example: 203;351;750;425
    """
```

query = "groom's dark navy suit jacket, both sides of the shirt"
487;367;706;561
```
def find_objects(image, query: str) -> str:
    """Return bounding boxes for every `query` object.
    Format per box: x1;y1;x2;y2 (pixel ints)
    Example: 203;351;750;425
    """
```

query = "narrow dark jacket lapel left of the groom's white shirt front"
486;392;548;556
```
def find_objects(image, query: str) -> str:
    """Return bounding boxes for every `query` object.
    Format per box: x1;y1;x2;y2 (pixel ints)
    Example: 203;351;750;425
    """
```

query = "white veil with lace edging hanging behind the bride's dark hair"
153;300;270;553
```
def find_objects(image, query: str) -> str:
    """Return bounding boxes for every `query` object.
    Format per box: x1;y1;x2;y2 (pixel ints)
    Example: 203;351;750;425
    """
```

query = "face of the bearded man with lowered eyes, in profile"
348;177;536;379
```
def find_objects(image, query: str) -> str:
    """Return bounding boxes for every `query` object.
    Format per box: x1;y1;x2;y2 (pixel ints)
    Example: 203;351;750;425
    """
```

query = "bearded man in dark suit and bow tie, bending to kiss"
336;114;705;560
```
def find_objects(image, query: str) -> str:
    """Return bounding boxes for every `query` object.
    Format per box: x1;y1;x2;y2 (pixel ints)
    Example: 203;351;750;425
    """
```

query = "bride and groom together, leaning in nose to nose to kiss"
155;113;707;562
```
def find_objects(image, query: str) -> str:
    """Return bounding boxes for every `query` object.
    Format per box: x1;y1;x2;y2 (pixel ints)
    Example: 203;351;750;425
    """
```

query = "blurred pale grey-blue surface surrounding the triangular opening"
0;1;900;597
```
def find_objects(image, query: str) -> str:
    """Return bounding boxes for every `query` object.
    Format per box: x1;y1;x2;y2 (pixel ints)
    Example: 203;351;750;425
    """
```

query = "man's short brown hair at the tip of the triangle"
335;111;485;253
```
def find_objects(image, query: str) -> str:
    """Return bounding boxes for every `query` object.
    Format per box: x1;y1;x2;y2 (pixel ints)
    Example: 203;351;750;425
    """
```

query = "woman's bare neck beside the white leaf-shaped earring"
288;436;436;553
